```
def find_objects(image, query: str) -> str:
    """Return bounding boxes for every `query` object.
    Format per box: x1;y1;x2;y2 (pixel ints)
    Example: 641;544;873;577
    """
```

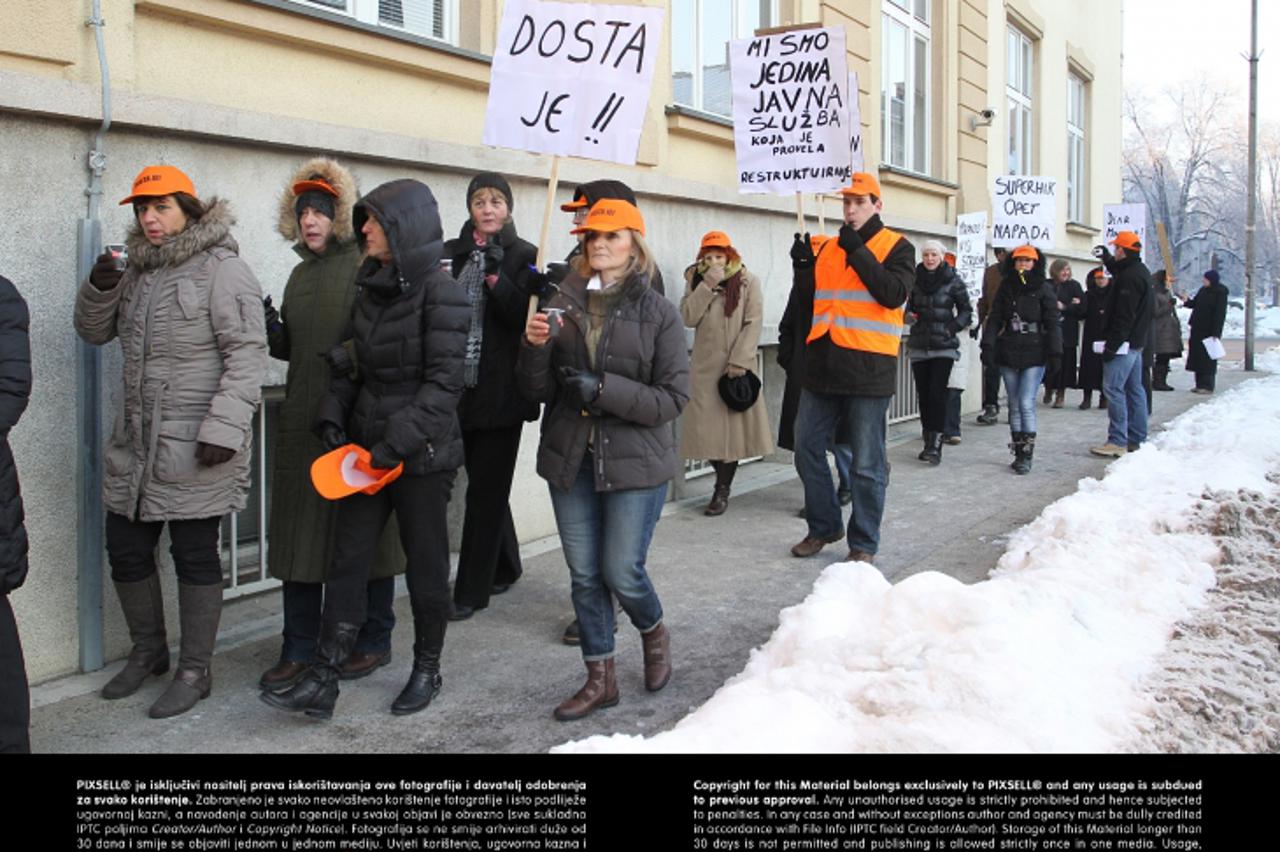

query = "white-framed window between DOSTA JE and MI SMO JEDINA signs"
671;0;778;116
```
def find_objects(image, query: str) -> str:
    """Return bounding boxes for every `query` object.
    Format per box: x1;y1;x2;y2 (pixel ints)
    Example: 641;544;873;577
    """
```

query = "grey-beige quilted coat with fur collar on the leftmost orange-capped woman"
76;198;266;521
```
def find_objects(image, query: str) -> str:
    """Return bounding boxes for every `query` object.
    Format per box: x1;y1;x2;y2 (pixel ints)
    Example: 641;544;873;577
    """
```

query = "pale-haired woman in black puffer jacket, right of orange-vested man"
906;239;973;464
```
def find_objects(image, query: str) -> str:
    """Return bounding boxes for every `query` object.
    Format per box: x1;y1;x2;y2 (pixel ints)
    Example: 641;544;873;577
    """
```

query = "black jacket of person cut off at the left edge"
0;276;31;595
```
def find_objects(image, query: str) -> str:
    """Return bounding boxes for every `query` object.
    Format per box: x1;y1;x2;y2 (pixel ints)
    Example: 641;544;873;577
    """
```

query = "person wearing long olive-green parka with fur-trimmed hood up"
259;157;404;690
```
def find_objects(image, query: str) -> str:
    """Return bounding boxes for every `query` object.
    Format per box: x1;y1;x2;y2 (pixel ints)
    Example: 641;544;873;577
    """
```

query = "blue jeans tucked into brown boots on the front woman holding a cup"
550;453;665;661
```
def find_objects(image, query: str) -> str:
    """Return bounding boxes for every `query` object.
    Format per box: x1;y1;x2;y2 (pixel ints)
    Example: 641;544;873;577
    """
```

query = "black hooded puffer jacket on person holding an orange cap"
316;179;470;475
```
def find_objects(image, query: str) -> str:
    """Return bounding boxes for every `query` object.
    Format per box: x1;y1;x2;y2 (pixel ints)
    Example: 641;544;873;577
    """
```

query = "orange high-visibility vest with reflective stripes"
805;228;905;356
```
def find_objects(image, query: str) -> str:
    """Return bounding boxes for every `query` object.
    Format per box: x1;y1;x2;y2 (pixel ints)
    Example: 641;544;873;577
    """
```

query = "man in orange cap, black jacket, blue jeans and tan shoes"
1089;230;1152;458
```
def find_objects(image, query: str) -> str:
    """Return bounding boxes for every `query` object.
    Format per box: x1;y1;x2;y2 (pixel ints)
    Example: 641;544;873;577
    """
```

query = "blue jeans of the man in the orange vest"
796;390;892;554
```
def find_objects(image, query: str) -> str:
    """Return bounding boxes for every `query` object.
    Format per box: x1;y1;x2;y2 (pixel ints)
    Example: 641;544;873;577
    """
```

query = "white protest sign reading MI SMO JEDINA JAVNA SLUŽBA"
730;27;860;193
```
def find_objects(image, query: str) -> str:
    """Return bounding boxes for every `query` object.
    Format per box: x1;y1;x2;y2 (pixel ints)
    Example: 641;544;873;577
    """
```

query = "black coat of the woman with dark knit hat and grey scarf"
444;220;538;430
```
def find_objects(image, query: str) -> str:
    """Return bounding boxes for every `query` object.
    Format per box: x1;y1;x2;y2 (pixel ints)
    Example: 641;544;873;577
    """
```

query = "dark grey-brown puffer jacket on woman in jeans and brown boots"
516;272;689;491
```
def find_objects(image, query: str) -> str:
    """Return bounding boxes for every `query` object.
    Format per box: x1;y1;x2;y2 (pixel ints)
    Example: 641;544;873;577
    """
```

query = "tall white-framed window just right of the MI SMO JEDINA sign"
881;0;932;174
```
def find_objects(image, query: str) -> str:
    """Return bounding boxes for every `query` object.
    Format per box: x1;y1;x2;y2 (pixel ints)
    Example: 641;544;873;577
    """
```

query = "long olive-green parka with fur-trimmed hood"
268;157;404;583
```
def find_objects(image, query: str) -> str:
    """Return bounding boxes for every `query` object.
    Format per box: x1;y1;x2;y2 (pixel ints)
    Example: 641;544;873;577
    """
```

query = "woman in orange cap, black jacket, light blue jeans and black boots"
982;246;1062;475
